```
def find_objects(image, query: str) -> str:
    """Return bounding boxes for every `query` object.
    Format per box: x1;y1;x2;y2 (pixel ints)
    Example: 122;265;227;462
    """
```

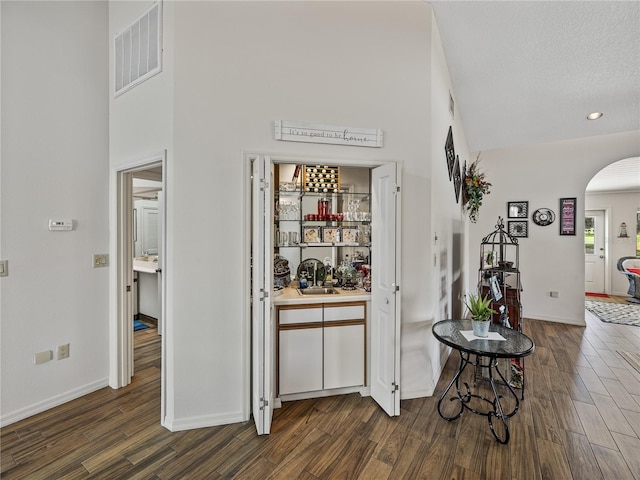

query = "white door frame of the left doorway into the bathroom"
109;151;167;425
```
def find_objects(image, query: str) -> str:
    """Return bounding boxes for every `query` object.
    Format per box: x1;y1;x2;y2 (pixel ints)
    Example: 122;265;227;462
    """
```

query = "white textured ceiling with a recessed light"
431;1;640;151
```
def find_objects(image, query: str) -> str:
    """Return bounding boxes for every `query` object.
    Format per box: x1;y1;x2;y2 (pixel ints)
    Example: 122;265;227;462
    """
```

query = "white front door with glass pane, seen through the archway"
584;210;606;293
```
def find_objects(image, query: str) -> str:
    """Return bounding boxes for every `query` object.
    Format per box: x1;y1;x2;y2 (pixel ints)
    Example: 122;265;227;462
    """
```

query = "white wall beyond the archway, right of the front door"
584;188;640;295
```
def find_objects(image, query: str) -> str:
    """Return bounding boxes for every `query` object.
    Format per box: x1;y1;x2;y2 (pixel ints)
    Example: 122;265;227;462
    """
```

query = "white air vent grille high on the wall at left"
114;3;162;97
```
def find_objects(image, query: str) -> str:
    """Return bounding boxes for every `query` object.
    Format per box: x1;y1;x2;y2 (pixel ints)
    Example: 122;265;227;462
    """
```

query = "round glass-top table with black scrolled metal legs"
432;320;535;443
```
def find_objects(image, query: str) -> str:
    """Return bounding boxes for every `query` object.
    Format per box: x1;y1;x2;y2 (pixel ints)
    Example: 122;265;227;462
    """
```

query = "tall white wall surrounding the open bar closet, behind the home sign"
165;2;438;422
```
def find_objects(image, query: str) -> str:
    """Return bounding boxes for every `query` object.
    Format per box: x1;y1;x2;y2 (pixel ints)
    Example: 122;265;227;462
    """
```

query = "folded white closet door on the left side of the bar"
251;156;274;435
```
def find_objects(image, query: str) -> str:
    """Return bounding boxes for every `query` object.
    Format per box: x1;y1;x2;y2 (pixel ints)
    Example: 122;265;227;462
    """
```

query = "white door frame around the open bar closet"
242;152;402;432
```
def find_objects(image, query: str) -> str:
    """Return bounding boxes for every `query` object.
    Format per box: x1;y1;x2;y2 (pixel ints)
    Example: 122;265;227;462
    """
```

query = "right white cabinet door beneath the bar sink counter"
324;325;364;389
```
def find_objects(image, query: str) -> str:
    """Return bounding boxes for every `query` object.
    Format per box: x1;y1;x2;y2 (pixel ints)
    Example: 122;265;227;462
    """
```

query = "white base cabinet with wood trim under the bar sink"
277;302;366;395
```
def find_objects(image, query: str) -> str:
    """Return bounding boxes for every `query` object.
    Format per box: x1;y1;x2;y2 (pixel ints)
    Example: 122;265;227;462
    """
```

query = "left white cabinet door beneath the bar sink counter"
279;327;322;395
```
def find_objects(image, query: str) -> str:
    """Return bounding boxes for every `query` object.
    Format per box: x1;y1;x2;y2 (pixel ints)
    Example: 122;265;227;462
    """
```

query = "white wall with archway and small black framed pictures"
469;131;640;324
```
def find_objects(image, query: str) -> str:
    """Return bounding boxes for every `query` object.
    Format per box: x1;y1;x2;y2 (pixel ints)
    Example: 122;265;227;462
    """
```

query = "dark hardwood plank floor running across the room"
0;298;640;480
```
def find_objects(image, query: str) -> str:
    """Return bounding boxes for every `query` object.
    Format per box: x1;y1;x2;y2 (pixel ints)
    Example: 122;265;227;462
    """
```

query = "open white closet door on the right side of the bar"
371;163;400;416
